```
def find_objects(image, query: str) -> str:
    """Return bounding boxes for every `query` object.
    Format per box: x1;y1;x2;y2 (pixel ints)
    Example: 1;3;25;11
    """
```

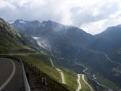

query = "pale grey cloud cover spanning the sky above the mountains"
0;0;121;32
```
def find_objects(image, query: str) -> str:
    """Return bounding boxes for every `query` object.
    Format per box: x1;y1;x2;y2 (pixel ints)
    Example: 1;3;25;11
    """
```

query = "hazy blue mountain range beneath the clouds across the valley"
12;20;121;87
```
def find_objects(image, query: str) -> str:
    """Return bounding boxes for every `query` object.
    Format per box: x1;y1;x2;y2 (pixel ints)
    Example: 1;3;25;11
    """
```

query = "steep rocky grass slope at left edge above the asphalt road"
0;18;22;53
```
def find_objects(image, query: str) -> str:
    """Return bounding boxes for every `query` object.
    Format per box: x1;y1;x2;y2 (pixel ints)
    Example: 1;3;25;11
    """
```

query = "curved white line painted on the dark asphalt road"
0;60;16;91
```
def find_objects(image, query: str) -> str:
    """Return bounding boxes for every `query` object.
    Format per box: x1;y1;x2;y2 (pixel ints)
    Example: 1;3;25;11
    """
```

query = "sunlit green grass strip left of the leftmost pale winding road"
22;55;61;82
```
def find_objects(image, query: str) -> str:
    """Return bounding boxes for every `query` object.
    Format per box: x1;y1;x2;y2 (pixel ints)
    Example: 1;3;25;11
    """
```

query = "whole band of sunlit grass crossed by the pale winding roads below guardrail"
22;54;93;91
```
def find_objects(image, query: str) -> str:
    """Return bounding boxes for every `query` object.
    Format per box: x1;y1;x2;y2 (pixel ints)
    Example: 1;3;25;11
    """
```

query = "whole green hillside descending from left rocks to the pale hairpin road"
0;19;94;91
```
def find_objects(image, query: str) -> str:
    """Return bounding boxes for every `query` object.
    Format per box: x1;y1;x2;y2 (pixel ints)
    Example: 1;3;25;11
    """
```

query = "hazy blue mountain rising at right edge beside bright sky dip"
92;25;121;63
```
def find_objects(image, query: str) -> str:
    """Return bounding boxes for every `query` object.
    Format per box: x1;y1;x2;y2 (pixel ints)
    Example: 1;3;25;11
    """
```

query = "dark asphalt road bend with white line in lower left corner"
0;58;25;91
